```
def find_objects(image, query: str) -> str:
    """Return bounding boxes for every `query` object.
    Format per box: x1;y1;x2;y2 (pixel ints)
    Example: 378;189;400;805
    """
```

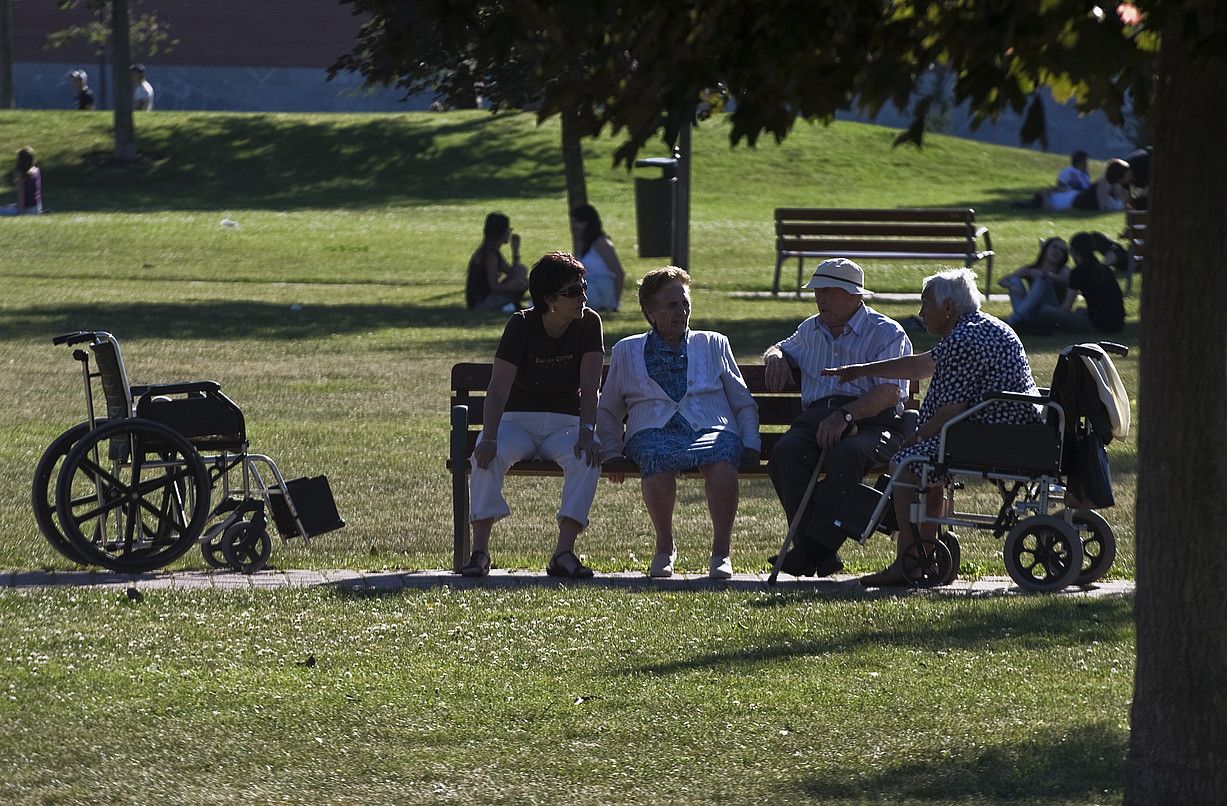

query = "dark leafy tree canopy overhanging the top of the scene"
333;0;1169;163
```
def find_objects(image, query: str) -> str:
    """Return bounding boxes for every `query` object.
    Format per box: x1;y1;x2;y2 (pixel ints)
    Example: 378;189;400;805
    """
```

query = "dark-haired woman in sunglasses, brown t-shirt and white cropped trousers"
460;251;605;579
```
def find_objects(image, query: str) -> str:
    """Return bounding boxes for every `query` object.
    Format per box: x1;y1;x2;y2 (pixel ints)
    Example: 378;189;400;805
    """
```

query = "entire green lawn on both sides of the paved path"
0;112;1144;804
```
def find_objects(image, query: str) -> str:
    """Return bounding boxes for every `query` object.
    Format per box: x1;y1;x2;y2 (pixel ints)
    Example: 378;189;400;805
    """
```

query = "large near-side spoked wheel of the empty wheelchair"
55;418;210;572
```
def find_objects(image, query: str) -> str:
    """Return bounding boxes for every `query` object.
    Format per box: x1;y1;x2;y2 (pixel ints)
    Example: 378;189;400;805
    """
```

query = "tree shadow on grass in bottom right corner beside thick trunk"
799;715;1129;804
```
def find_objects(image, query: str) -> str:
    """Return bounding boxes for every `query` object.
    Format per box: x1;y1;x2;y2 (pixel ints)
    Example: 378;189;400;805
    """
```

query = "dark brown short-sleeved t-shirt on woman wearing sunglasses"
494;308;605;416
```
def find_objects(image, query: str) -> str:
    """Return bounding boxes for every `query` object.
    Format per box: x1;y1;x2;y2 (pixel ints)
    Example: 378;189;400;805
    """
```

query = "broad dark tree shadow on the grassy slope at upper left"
56;114;564;212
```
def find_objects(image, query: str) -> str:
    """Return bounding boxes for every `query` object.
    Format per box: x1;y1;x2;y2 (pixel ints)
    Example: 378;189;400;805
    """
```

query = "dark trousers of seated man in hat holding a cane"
767;404;901;562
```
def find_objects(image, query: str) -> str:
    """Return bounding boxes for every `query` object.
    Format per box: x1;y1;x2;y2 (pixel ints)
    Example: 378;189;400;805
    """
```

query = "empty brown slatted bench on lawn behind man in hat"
772;207;994;296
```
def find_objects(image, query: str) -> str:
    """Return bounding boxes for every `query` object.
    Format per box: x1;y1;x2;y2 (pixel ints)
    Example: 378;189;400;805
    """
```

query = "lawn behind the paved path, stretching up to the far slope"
0;112;1137;575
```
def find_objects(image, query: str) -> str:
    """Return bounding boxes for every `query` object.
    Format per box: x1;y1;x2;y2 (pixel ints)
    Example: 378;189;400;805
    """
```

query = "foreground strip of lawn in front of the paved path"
0;586;1134;806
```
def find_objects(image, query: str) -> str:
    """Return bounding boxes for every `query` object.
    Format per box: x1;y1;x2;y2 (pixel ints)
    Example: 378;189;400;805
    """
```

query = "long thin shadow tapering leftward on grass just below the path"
627;597;1133;675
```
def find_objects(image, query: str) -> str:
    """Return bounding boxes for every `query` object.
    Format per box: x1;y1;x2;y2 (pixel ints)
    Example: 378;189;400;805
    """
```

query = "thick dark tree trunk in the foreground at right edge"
1125;0;1227;806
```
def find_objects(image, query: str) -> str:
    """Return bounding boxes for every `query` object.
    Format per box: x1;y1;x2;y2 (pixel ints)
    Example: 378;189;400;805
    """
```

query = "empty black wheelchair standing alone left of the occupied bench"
32;331;345;573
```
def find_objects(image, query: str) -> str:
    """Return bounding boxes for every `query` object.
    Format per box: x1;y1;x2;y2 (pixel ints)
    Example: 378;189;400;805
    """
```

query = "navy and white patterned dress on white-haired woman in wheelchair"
893;310;1044;461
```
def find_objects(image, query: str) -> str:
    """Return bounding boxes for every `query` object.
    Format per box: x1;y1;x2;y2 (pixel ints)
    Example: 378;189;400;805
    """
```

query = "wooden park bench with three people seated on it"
447;363;801;570
